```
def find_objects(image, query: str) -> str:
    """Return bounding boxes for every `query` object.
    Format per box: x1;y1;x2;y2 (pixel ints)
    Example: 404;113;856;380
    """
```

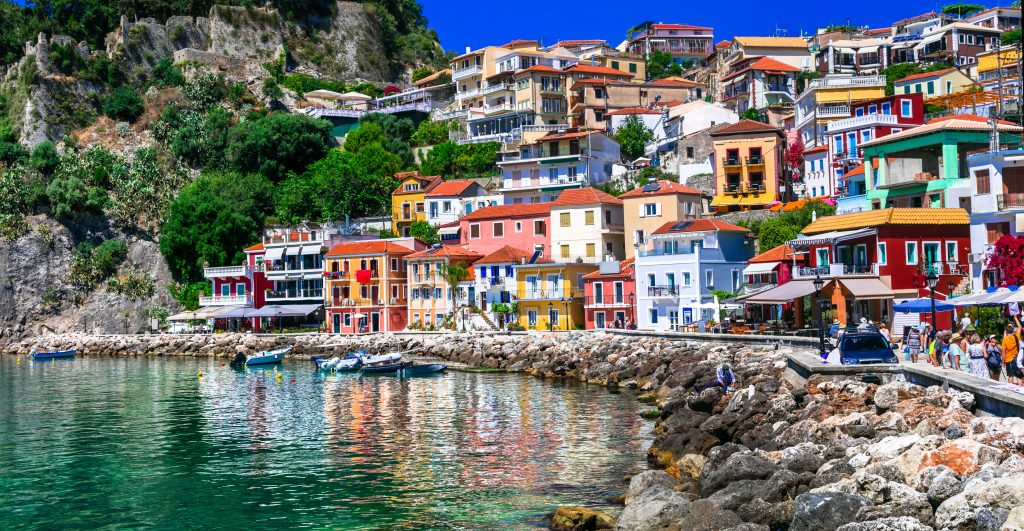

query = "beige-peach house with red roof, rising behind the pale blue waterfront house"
618;179;703;258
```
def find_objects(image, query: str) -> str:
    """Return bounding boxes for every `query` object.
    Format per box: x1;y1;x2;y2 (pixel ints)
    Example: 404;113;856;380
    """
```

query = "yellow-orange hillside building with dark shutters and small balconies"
711;120;784;213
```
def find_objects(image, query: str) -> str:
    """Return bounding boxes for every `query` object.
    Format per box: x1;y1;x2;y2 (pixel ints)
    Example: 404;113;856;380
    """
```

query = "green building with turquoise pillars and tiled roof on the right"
861;115;1021;211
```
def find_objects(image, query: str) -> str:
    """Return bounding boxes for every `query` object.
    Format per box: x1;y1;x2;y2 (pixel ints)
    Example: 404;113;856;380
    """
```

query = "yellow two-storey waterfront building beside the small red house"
515;263;598;330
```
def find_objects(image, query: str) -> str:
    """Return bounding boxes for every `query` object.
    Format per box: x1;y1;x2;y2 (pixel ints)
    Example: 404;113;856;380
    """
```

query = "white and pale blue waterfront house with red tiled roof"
634;218;754;331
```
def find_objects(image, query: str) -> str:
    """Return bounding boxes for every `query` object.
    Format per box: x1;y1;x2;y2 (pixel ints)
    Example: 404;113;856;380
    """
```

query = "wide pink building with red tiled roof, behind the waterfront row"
459;203;551;258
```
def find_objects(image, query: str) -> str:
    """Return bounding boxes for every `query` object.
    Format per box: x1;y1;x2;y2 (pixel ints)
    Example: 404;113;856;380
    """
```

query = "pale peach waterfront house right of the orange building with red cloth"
406;246;482;328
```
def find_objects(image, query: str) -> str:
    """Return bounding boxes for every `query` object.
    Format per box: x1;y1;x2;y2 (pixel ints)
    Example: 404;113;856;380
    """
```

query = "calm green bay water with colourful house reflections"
0;356;650;530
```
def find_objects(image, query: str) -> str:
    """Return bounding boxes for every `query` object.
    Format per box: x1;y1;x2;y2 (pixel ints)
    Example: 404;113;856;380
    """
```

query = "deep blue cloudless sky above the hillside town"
420;0;954;53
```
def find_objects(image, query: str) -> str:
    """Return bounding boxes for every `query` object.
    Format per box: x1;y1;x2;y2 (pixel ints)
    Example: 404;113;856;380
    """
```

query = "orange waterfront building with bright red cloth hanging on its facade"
322;238;417;334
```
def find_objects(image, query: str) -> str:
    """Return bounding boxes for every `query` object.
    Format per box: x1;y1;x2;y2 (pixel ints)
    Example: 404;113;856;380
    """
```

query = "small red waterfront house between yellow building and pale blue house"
583;258;636;329
